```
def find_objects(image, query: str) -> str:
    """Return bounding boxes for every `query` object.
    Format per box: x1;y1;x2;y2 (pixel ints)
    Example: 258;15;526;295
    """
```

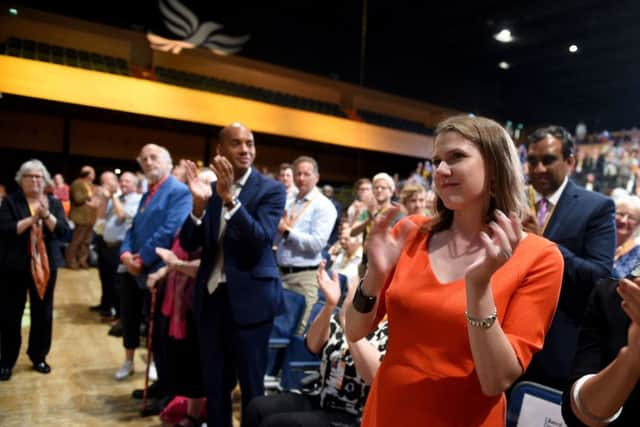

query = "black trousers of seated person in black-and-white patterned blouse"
242;393;358;427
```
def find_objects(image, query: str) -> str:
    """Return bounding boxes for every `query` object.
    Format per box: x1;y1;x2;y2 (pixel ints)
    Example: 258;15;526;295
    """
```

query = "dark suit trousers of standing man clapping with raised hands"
196;283;273;427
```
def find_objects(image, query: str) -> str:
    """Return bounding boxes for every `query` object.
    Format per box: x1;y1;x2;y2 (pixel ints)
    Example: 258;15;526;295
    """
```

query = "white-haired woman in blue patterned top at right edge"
613;196;640;278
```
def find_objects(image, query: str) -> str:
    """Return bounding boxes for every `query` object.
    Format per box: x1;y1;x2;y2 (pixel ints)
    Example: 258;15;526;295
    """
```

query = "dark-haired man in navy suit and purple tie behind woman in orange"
525;126;616;388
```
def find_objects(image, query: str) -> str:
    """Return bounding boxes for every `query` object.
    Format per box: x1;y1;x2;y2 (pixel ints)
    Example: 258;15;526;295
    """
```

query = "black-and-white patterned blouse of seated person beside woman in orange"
320;314;389;416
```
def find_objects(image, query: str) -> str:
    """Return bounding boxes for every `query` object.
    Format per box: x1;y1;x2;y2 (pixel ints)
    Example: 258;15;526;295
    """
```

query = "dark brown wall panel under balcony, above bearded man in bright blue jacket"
69;120;206;163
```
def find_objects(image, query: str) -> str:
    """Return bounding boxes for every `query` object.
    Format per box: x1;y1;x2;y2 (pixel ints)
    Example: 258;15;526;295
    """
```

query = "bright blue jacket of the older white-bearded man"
120;175;191;282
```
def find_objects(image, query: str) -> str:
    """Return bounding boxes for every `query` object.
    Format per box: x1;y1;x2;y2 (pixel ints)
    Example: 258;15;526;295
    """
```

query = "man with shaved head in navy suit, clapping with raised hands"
180;123;286;427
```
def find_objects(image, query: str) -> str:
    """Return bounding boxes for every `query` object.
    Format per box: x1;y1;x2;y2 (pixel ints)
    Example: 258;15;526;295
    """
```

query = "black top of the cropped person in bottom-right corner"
562;282;640;427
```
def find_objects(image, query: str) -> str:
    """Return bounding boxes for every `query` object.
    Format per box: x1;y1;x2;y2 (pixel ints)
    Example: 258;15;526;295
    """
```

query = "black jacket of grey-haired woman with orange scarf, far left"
0;190;69;272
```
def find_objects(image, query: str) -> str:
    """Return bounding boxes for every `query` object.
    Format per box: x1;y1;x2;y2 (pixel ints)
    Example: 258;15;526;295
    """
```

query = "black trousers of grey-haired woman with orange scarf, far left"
0;269;58;368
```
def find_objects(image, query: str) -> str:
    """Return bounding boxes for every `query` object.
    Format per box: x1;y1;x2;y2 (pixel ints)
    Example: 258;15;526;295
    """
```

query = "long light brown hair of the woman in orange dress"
428;116;530;232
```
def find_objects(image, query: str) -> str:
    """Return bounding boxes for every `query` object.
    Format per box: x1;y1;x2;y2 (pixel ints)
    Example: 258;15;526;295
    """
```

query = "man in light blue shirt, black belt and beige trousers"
277;156;338;333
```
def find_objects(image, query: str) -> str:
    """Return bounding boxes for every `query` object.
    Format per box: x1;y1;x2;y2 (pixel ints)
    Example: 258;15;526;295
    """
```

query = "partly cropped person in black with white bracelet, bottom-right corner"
562;279;640;427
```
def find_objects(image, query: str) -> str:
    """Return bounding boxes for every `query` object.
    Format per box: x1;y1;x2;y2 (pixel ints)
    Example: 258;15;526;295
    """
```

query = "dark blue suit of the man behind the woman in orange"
529;180;616;388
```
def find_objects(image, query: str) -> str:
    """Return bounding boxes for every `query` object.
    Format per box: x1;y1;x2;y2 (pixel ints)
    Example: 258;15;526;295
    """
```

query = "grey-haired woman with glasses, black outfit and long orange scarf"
0;159;68;381
